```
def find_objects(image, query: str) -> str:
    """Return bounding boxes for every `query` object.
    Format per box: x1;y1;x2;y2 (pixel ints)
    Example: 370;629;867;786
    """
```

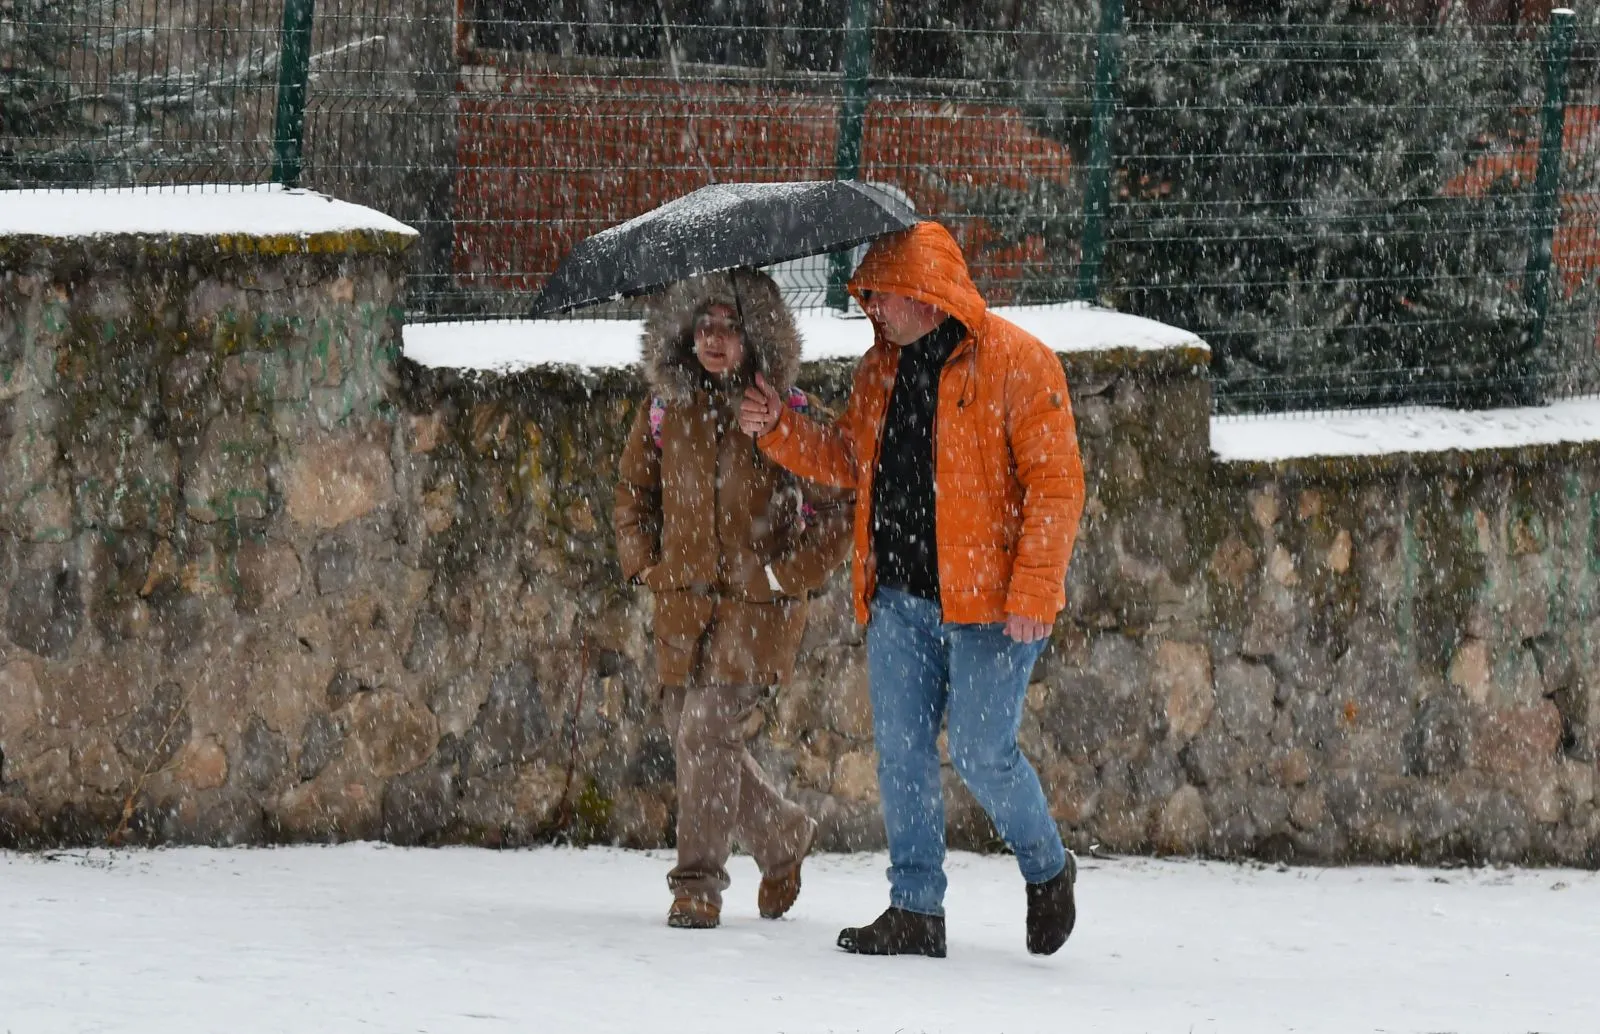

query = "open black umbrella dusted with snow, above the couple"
533;179;917;315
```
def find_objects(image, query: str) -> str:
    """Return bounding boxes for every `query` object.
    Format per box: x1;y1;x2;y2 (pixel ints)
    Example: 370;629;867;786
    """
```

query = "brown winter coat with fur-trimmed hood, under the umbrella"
614;271;851;685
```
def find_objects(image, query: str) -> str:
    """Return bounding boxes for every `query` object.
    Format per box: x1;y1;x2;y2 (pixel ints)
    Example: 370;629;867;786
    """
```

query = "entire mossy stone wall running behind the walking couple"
0;224;1600;866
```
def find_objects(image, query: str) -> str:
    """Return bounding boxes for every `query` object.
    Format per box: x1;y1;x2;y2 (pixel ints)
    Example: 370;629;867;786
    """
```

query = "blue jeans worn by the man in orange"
867;587;1067;916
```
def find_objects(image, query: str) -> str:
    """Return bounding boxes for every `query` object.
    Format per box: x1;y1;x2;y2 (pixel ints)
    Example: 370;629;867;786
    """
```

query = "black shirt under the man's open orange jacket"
872;319;966;602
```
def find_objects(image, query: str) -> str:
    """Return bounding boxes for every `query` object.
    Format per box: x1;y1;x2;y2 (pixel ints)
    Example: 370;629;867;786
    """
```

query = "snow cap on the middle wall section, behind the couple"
405;303;1206;373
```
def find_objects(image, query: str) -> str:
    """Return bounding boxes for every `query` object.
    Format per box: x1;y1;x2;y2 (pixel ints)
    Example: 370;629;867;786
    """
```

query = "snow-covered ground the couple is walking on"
0;844;1600;1034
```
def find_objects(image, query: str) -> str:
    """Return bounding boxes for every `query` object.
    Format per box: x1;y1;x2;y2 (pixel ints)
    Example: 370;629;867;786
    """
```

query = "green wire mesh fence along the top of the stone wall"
0;0;1600;411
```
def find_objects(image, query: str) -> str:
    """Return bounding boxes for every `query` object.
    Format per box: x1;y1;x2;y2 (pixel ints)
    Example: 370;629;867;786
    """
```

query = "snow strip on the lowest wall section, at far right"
1211;399;1600;463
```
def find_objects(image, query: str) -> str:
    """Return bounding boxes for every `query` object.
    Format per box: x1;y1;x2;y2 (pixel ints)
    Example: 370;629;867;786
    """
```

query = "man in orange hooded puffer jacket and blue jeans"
741;222;1083;957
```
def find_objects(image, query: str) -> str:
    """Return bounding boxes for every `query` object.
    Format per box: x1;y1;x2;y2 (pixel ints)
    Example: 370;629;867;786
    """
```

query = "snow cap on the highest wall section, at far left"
0;184;416;237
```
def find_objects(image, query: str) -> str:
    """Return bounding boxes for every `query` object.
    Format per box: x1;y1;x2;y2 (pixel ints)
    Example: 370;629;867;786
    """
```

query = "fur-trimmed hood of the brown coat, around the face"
640;269;800;402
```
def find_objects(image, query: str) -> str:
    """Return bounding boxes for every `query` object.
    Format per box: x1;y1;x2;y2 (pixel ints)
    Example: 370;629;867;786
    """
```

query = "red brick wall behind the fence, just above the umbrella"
454;69;1072;301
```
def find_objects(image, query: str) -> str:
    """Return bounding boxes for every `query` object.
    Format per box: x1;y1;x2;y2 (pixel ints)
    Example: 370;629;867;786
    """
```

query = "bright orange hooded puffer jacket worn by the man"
760;222;1083;623
